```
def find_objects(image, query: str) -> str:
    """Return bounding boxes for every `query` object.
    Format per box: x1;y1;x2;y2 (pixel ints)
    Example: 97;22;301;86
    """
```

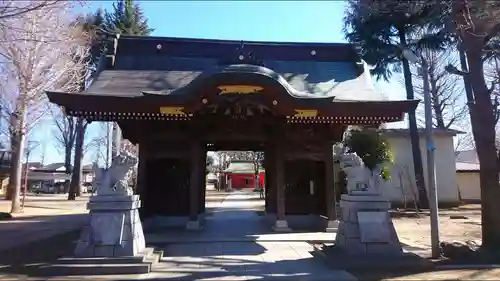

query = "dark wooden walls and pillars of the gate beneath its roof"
138;129;336;231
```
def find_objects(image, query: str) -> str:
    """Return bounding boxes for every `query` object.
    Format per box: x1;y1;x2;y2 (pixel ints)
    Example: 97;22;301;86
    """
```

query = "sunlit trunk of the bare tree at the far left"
8;110;28;213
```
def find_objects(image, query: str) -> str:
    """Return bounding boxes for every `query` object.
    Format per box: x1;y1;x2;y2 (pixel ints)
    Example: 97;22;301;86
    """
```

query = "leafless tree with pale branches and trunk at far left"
0;0;89;208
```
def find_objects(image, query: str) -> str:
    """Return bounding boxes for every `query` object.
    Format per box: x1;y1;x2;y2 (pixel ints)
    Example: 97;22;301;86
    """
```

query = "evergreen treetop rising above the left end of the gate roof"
105;0;154;36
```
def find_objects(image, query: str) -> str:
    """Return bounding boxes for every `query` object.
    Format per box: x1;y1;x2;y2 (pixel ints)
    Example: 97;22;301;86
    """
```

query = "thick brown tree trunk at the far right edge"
465;44;500;249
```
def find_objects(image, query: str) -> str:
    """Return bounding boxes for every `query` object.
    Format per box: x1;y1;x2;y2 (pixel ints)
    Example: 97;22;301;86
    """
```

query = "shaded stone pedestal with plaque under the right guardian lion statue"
335;191;403;256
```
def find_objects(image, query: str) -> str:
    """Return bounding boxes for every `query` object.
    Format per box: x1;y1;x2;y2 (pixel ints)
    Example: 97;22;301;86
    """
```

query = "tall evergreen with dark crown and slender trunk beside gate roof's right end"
344;0;446;208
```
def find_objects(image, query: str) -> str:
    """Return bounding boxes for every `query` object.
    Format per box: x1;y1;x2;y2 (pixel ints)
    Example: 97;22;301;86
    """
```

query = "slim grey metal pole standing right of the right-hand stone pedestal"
421;58;441;258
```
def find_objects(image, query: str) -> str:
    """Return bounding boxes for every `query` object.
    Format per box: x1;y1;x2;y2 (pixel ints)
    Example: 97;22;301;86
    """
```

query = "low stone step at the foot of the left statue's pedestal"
40;248;163;276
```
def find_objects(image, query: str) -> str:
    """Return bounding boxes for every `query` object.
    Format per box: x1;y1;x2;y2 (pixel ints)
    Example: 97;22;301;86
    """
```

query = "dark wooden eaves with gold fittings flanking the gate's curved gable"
49;92;418;125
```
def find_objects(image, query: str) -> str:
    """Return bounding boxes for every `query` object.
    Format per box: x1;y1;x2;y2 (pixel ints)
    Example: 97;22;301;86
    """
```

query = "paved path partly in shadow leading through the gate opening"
146;192;356;280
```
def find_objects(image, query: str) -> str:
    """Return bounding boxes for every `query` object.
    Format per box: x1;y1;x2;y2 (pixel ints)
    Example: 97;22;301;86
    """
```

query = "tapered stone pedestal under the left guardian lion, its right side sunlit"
74;195;146;257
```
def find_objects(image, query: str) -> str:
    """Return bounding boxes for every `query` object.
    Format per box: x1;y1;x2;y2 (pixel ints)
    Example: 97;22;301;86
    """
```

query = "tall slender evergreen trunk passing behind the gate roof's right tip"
399;29;429;208
